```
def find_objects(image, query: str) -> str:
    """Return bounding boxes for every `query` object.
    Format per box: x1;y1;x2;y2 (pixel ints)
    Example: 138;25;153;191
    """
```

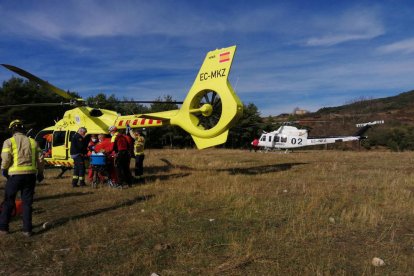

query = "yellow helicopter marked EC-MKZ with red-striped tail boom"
2;46;243;170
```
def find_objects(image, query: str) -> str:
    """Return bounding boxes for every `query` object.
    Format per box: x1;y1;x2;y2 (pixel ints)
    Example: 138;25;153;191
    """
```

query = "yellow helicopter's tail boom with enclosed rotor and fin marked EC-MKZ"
117;46;243;149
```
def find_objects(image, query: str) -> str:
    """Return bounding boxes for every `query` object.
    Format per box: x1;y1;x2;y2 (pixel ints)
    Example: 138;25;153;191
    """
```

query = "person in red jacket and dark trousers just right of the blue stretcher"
109;126;132;186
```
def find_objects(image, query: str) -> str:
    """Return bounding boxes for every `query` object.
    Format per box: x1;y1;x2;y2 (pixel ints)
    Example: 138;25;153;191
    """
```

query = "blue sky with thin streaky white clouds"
0;0;414;116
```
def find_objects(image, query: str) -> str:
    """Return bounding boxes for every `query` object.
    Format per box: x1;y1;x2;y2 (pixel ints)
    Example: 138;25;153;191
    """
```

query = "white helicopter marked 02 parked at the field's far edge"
252;121;384;151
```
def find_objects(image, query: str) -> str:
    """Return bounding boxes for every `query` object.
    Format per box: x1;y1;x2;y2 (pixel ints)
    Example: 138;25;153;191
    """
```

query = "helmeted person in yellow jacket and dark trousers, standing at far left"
0;120;44;237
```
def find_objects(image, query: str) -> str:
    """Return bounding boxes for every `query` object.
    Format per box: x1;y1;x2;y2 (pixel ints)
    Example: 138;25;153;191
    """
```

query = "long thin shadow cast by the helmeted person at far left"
34;195;155;235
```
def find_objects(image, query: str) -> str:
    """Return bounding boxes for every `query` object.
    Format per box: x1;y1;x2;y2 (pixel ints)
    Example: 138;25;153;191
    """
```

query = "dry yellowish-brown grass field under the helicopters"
0;149;414;275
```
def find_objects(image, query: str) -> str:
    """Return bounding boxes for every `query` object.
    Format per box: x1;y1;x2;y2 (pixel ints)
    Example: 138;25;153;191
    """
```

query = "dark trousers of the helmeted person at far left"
0;174;36;232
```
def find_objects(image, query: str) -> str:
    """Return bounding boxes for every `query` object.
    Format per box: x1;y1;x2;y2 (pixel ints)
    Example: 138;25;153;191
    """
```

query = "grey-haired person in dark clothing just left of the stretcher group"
70;127;88;188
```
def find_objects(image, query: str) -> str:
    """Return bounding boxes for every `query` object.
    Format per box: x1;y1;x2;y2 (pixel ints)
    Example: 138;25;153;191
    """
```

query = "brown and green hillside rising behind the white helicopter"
273;90;414;151
